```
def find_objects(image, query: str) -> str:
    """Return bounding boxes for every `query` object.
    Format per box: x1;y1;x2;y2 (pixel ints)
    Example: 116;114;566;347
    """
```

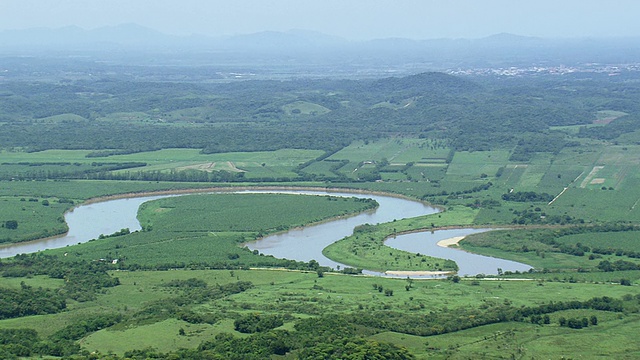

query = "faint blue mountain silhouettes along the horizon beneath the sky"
0;24;639;50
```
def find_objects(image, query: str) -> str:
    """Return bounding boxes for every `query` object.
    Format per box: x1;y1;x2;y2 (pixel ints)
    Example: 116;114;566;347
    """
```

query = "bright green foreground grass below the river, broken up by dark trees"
0;270;640;358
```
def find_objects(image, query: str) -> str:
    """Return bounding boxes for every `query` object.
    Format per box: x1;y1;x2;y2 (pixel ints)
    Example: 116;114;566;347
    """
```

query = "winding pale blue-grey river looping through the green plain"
0;190;529;275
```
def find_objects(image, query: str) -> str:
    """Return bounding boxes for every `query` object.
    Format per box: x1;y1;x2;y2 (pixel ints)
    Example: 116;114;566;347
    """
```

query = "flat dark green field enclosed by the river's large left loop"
47;194;373;268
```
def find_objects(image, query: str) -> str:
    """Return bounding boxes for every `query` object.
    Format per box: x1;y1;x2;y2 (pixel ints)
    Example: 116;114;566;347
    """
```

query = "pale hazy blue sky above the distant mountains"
5;0;640;40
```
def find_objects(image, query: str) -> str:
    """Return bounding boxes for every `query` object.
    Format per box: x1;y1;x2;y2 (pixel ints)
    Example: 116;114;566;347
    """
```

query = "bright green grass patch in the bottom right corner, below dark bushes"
373;310;640;359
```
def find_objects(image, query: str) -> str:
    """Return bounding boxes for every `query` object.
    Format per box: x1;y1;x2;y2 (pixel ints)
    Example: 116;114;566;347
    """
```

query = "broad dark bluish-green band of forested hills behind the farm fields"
0;65;640;153
